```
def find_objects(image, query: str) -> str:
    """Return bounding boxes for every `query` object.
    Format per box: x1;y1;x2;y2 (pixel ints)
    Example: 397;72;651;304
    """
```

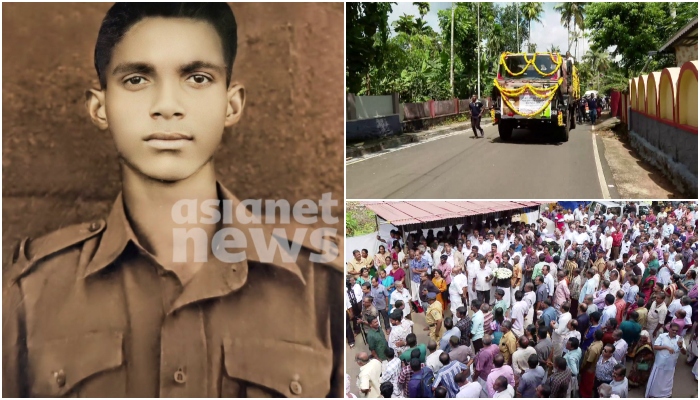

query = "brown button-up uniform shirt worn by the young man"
3;186;343;397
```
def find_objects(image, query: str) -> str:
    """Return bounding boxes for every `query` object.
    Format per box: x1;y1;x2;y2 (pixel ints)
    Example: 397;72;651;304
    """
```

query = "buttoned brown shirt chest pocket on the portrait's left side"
28;332;126;397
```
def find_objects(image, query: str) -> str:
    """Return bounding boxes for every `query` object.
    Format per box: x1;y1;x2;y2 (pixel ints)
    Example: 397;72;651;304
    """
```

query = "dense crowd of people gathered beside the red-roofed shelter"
346;203;698;398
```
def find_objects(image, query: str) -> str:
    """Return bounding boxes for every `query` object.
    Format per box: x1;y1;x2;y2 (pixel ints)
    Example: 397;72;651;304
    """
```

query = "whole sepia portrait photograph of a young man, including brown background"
2;3;345;398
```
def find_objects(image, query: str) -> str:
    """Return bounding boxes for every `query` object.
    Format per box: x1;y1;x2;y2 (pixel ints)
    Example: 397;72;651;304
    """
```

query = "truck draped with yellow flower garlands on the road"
491;53;580;142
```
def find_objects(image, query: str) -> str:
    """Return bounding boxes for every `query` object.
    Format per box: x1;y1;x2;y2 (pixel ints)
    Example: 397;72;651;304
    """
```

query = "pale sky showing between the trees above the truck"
389;2;588;58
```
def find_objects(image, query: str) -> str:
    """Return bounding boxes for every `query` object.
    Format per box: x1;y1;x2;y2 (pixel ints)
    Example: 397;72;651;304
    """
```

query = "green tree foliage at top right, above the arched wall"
585;2;698;77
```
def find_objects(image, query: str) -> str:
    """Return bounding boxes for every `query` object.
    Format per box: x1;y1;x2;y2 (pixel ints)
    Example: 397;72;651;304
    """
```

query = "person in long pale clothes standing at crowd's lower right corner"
645;322;686;397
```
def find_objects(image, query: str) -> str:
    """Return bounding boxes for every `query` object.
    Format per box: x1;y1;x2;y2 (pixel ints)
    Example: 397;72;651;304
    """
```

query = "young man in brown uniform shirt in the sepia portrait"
3;3;343;397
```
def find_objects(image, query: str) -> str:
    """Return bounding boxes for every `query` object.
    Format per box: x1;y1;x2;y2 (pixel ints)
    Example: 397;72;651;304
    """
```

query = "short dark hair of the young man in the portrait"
95;2;238;89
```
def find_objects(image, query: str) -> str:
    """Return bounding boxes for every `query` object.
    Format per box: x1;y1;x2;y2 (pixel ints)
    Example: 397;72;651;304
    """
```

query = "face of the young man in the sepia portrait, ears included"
97;18;244;182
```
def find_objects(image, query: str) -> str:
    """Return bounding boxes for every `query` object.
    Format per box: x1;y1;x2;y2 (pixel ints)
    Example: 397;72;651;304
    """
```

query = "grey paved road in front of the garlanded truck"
346;120;603;199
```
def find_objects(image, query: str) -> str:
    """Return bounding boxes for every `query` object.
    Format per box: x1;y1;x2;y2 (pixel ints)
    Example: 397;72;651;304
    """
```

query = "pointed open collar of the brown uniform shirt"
84;182;306;290
